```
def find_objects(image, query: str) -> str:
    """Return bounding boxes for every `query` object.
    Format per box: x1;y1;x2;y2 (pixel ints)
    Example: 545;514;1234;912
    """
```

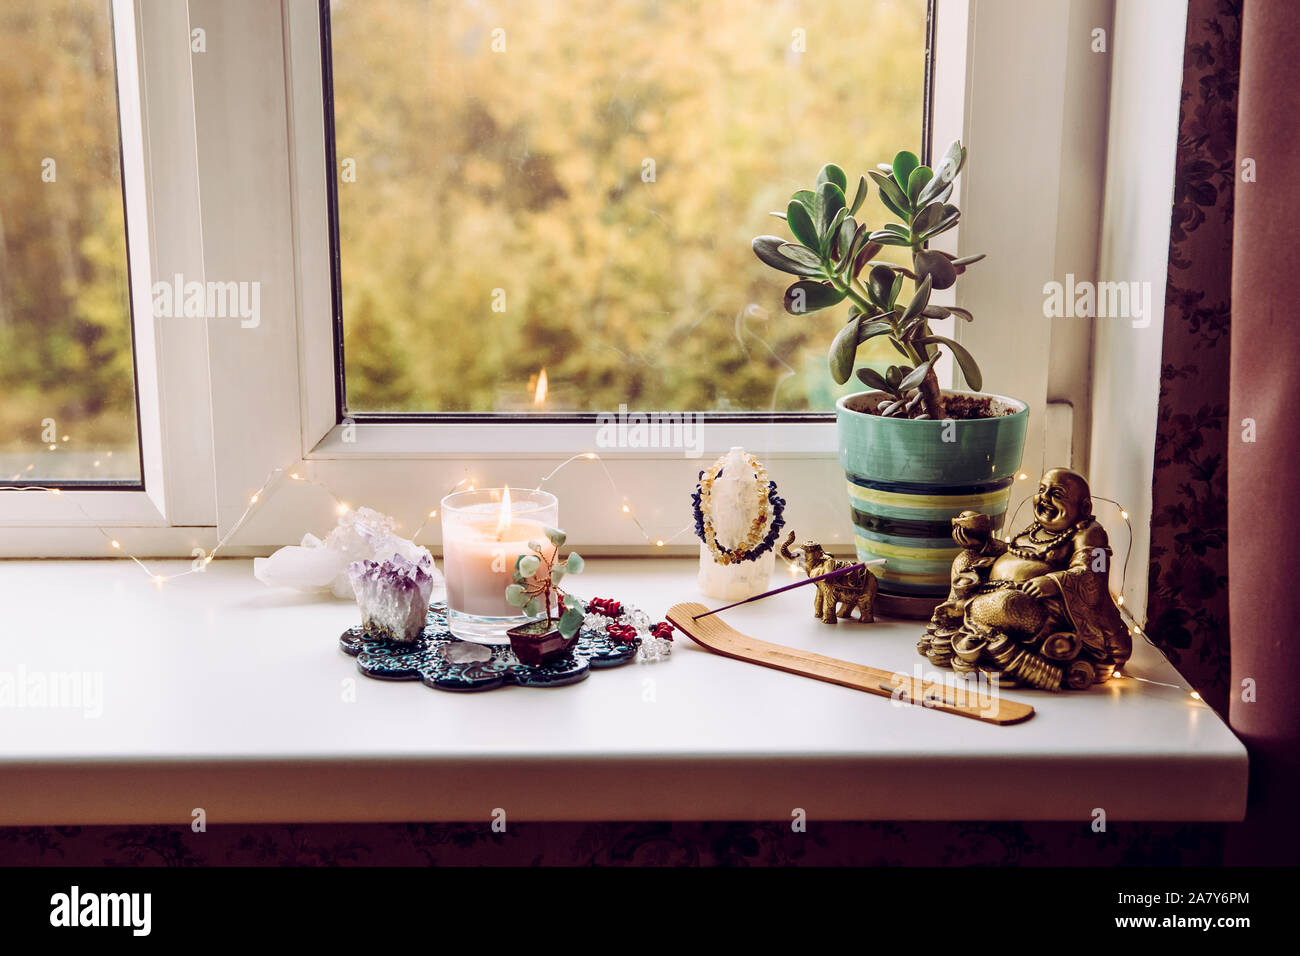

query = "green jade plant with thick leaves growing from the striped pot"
754;142;984;419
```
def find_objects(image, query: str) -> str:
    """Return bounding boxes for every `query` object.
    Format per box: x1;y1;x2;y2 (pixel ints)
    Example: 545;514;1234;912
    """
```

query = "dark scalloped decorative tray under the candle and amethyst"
338;601;641;691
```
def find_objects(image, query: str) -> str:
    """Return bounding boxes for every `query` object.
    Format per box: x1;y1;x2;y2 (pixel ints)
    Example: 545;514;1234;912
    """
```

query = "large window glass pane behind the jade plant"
330;0;926;412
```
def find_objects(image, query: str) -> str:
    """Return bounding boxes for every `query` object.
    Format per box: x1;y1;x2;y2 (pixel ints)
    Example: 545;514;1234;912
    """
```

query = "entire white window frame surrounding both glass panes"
0;0;1109;555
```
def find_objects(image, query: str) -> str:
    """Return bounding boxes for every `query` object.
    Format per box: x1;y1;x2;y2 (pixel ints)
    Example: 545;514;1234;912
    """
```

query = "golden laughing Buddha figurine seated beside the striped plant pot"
917;468;1132;691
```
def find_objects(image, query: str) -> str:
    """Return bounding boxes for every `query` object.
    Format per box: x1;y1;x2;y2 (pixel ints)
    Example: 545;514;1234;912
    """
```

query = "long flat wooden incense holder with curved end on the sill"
668;601;1034;724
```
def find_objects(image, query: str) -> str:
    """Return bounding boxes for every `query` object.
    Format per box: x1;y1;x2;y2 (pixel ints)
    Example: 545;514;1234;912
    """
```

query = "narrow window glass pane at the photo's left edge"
0;0;140;483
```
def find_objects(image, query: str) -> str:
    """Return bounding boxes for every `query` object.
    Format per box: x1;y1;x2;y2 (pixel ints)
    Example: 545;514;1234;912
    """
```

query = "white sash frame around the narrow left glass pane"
0;0;216;557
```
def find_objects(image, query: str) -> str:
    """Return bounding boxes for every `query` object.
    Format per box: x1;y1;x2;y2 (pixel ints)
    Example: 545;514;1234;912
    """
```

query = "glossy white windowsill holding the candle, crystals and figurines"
0;558;1247;827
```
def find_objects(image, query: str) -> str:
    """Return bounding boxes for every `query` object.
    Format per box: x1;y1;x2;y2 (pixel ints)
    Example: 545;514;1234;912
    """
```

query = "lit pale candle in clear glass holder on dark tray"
441;488;559;644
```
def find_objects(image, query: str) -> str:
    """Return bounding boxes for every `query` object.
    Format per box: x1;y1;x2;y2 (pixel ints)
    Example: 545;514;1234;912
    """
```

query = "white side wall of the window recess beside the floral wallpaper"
1089;0;1187;619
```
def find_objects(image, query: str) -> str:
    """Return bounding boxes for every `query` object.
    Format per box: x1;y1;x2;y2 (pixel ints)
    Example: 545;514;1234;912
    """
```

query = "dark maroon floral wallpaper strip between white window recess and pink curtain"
1147;0;1242;715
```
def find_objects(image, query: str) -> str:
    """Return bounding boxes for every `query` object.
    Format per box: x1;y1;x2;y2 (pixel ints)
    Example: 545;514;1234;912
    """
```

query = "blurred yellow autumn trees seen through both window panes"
0;0;926;480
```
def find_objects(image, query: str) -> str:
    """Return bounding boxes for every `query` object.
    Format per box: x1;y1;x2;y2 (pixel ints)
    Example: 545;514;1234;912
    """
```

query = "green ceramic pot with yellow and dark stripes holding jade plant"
836;392;1030;598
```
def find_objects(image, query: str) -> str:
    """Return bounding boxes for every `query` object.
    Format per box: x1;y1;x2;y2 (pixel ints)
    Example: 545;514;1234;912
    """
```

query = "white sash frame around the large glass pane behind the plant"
248;0;1100;554
